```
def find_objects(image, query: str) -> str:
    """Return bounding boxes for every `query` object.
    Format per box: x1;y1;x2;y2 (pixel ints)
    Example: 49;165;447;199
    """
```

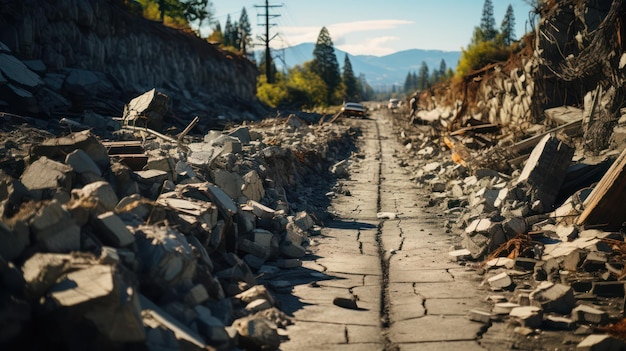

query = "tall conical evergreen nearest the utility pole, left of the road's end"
311;27;341;104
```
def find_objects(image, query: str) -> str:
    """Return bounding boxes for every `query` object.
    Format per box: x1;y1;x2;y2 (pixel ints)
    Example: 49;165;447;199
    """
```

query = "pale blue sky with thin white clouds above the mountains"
203;0;538;56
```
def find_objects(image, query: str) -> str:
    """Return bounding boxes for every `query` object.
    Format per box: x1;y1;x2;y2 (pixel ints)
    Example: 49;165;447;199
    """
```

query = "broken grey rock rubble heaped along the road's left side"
0;102;353;350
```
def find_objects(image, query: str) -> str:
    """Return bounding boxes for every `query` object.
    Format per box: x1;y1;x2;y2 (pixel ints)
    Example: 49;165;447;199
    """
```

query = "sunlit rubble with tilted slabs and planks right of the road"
396;99;626;349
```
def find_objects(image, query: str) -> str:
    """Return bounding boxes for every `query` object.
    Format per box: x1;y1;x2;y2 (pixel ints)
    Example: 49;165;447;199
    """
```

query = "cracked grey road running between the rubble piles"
278;115;488;351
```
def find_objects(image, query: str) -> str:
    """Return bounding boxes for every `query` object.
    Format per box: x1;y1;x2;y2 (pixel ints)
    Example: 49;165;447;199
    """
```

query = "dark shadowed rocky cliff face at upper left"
0;0;257;125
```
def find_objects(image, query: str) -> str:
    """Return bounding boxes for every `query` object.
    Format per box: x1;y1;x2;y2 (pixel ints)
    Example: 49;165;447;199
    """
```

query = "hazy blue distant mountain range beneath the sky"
262;43;461;90
